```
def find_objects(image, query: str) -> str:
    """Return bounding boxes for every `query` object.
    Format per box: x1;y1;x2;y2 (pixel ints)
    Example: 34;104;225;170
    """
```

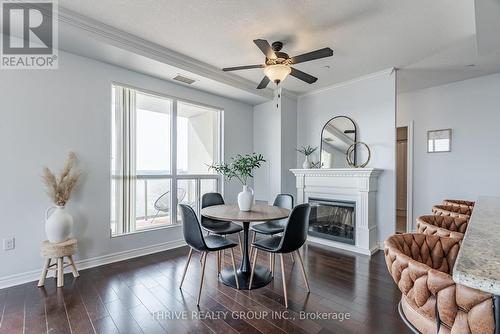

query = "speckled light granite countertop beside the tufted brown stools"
453;197;500;295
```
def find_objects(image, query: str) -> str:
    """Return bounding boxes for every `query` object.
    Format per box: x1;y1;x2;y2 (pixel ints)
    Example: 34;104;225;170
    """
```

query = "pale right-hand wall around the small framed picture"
397;74;500;226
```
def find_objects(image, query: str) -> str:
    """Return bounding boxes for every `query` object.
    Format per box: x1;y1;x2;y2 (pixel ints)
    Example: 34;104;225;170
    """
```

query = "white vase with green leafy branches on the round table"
208;153;266;211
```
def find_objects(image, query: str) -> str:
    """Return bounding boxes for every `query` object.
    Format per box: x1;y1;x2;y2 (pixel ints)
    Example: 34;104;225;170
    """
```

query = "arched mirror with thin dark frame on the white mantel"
319;116;357;168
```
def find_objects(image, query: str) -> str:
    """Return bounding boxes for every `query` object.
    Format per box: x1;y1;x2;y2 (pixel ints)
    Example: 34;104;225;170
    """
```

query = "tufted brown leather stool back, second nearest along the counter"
417;215;468;239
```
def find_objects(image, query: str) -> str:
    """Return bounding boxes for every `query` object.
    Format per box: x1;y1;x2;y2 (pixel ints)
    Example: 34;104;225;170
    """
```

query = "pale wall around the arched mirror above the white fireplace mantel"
297;71;396;242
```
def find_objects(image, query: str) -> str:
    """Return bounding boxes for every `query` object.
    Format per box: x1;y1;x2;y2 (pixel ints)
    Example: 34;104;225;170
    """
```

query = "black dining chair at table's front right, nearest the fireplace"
248;203;311;308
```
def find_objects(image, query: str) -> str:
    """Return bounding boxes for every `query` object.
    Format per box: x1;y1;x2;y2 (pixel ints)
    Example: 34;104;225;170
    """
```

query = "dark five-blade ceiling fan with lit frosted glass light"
222;39;333;89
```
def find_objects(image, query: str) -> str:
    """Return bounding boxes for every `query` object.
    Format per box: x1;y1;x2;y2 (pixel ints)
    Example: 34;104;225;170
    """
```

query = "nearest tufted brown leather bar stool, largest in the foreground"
384;233;495;334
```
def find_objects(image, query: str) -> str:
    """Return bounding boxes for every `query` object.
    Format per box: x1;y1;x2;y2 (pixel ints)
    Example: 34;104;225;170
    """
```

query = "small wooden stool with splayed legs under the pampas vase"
38;239;80;288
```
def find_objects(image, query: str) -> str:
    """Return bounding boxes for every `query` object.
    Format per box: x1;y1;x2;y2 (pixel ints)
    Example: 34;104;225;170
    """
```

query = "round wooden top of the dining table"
201;204;290;222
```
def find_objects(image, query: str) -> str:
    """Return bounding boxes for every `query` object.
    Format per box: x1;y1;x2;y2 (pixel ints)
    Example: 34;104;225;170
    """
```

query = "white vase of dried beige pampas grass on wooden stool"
42;152;81;243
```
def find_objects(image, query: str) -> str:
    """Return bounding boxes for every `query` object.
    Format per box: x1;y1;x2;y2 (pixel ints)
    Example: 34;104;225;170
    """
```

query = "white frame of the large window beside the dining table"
109;81;224;238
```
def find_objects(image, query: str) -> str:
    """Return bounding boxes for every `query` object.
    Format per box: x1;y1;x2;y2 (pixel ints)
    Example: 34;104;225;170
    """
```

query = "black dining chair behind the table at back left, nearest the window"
201;193;243;271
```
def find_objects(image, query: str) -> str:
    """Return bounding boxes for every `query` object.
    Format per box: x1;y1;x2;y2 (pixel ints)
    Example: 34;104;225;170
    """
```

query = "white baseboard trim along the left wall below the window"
0;239;186;289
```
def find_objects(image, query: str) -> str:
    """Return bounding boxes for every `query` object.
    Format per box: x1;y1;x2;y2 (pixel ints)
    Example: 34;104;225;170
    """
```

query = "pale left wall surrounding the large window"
0;52;253;285
